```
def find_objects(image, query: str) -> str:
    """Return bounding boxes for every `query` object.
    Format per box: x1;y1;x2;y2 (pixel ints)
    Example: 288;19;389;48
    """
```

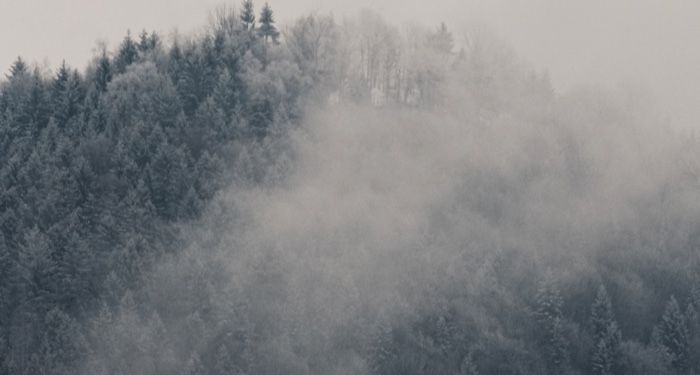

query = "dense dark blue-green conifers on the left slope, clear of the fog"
0;1;301;374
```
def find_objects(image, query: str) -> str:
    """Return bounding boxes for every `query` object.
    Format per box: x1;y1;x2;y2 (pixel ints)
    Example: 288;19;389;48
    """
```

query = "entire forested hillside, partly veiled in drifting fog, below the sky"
0;0;700;375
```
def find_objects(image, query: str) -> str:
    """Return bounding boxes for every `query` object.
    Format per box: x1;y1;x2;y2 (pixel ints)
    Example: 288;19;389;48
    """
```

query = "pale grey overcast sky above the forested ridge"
0;0;700;128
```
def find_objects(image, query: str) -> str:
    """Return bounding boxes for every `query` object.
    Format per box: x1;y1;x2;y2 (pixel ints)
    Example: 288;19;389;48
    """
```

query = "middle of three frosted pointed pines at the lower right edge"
591;285;622;375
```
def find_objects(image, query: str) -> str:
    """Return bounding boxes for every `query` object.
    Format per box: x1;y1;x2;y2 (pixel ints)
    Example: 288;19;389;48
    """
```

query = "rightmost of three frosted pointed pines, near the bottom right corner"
654;296;690;373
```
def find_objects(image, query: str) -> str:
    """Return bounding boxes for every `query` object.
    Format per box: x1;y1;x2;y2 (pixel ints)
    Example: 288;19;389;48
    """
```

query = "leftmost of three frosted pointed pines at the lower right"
535;275;569;374
